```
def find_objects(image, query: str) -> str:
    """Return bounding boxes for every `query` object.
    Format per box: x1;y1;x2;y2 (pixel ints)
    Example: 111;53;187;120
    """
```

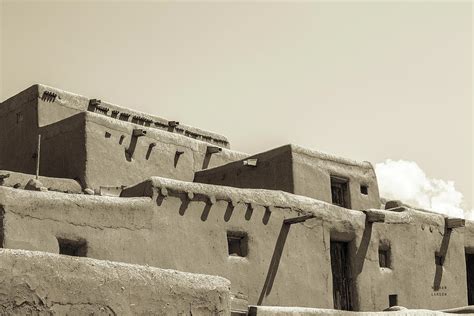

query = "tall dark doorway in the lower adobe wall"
331;241;353;311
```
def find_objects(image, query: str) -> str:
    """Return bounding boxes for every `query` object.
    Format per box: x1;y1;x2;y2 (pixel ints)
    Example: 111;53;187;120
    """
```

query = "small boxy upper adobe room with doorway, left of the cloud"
194;145;380;210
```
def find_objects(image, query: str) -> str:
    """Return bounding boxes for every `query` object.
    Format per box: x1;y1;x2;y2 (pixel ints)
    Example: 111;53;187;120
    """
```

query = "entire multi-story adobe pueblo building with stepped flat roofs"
0;85;474;315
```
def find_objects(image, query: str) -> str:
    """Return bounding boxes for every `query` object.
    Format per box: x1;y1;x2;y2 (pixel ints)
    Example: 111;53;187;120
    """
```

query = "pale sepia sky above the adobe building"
0;0;474;209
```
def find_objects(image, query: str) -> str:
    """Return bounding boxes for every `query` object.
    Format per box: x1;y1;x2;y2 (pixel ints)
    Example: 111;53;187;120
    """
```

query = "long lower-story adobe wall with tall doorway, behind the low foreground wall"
0;178;474;311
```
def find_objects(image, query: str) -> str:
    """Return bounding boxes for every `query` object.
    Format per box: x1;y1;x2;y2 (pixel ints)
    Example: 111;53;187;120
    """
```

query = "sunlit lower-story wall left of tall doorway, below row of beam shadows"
0;188;331;306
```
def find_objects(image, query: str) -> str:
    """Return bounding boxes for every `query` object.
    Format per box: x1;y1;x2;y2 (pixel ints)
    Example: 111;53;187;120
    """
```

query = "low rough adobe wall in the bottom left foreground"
0;249;230;316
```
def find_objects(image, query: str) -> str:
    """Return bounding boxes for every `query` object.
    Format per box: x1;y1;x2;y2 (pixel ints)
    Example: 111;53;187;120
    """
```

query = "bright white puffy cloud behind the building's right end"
375;159;466;219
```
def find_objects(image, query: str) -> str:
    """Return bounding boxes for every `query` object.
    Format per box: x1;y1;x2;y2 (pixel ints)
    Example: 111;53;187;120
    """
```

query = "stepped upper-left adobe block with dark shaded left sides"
0;85;247;191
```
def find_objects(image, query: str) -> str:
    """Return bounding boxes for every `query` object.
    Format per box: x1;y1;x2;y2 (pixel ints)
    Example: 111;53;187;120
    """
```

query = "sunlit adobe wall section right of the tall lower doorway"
356;211;467;310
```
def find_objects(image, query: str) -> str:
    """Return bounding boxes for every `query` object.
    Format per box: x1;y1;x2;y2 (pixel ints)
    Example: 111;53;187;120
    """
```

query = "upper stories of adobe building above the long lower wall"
0;84;380;210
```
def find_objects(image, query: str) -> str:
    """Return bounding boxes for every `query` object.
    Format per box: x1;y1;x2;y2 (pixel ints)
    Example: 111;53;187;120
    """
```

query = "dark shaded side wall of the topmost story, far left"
0;88;38;173
